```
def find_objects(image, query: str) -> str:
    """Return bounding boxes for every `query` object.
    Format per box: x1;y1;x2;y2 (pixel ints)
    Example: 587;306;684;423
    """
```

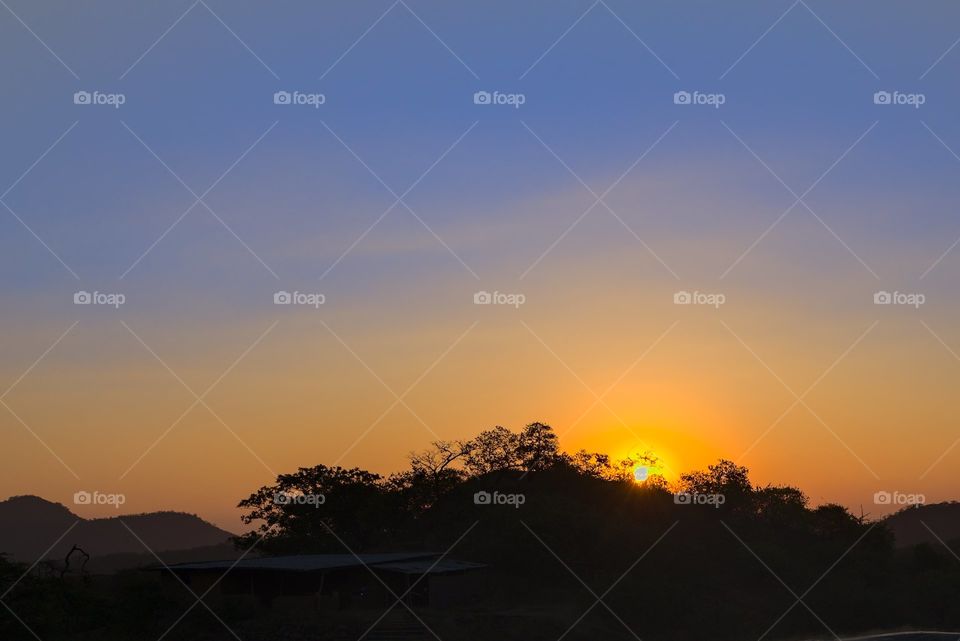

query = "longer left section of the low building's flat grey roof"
155;552;446;572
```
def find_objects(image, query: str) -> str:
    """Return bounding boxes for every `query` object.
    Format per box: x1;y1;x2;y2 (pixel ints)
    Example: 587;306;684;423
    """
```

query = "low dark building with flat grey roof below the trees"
160;552;485;612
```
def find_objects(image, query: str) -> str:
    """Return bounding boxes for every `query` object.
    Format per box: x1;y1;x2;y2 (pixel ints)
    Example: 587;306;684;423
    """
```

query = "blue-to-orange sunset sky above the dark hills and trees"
0;0;960;530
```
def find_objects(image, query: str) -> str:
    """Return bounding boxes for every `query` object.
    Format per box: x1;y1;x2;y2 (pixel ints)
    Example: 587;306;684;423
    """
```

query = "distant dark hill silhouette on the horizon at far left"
0;496;233;567
